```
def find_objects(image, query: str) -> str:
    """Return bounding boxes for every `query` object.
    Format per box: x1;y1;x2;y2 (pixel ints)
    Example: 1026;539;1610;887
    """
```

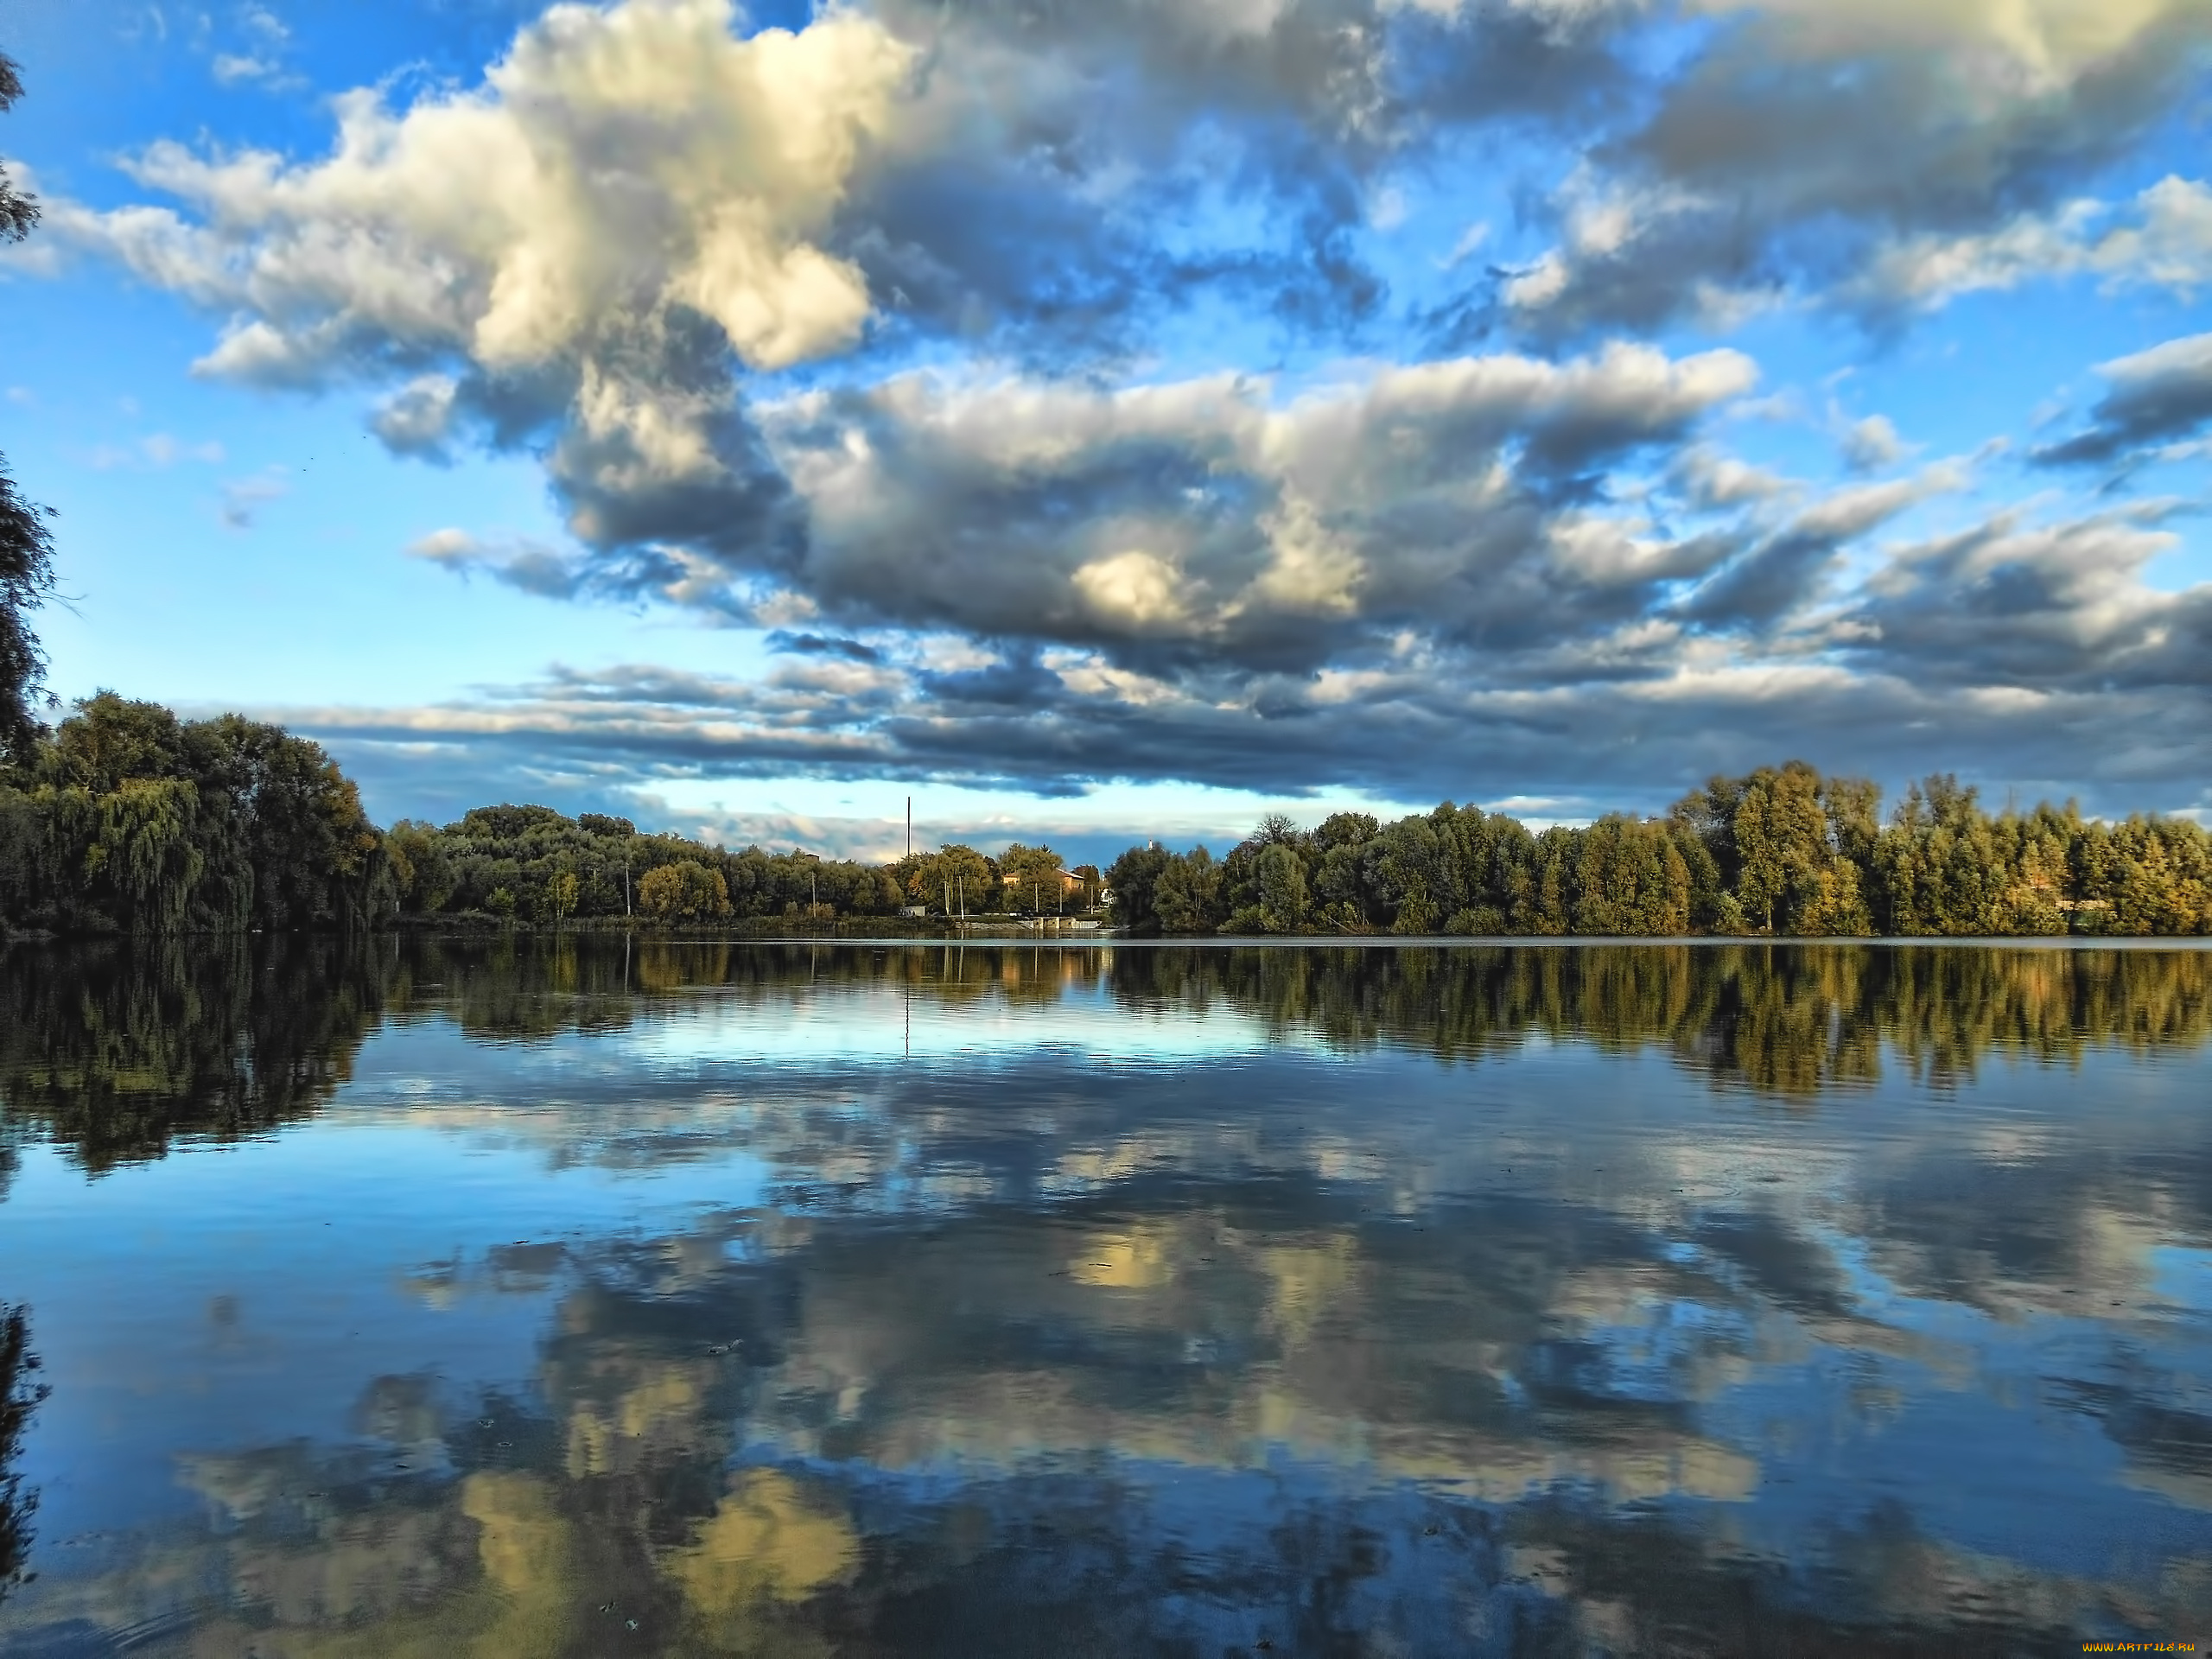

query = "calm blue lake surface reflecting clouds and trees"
0;940;2212;1659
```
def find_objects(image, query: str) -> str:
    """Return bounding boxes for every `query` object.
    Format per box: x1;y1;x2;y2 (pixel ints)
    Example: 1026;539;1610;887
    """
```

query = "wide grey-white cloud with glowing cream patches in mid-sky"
761;345;1757;668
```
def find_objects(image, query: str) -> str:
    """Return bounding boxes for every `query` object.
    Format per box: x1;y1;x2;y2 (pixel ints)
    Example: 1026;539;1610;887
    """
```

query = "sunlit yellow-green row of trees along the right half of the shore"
1109;761;2212;938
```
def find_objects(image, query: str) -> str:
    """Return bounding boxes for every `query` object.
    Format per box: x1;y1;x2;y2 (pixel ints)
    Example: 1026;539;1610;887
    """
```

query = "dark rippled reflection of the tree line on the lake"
0;933;2212;1174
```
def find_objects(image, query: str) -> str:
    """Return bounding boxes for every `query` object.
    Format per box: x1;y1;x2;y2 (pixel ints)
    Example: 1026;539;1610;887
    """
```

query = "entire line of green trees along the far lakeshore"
0;692;2212;938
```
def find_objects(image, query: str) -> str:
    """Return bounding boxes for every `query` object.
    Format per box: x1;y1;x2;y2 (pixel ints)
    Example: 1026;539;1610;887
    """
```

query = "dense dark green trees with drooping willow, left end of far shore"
0;692;394;933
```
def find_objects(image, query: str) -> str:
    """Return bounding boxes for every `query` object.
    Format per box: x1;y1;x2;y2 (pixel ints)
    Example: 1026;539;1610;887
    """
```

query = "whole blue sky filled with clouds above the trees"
0;0;2212;856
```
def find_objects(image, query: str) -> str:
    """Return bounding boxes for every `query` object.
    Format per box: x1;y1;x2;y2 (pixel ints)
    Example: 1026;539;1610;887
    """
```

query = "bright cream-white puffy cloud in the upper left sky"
51;0;912;393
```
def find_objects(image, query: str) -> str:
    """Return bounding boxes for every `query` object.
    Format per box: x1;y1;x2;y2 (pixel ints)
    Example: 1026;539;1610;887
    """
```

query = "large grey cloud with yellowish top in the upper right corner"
1497;0;2212;336
